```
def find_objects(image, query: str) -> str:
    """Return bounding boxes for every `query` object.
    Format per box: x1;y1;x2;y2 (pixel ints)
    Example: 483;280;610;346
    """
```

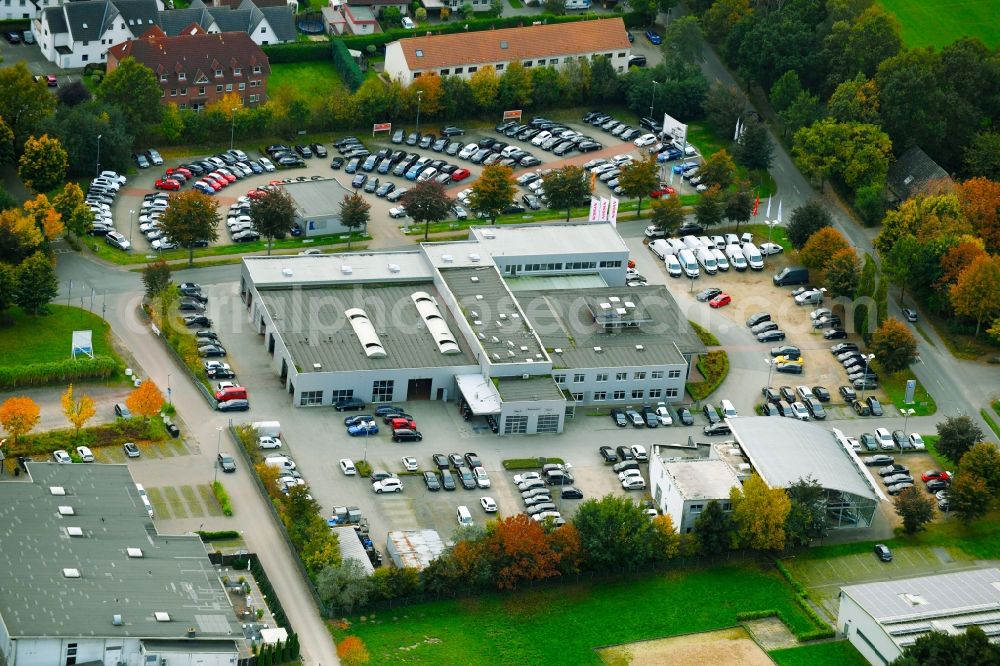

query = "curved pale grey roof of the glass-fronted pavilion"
726;416;885;501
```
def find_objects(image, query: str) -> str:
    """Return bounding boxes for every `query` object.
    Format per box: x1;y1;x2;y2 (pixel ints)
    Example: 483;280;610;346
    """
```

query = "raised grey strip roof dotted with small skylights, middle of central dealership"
440;263;549;363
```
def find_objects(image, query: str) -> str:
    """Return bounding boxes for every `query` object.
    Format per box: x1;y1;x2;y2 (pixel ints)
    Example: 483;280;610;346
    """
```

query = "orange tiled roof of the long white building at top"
399;18;631;71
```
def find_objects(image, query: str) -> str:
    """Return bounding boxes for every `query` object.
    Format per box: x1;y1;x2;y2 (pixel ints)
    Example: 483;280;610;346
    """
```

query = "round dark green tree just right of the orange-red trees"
573;495;654;571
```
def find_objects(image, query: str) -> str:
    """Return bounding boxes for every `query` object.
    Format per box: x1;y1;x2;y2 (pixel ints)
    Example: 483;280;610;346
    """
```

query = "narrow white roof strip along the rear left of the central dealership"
243;249;434;290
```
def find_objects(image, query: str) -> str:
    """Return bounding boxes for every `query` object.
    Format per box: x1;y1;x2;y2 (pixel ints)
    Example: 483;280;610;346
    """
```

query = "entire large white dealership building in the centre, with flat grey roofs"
240;223;704;434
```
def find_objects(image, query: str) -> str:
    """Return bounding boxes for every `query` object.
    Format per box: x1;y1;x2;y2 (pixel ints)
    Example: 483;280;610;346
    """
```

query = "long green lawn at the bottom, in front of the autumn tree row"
331;566;815;666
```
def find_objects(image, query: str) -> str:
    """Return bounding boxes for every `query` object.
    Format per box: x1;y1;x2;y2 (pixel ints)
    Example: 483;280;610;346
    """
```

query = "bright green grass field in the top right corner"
882;0;1000;49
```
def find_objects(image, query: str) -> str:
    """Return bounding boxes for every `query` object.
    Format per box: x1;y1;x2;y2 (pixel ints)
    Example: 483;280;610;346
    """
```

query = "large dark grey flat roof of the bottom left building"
0;463;242;639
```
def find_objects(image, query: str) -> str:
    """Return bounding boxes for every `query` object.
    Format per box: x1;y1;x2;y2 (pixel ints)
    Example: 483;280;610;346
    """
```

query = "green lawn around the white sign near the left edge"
0;304;117;367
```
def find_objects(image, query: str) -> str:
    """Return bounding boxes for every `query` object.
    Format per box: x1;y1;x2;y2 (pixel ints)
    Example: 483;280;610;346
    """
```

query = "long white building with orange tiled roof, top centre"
385;18;631;84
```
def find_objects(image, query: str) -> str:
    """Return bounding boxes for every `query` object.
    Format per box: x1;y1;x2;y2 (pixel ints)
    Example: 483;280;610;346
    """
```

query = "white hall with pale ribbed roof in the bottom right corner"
837;560;1000;666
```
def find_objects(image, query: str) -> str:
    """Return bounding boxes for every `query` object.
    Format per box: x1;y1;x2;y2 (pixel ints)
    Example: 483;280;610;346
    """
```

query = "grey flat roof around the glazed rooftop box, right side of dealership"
517;286;705;368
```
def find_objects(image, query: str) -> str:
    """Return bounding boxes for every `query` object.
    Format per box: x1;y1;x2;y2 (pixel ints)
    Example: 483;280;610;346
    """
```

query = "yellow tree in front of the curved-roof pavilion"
729;474;791;550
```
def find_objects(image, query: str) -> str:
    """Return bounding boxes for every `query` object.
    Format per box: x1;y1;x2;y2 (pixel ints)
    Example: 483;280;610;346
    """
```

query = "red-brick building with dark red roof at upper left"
108;24;271;111
